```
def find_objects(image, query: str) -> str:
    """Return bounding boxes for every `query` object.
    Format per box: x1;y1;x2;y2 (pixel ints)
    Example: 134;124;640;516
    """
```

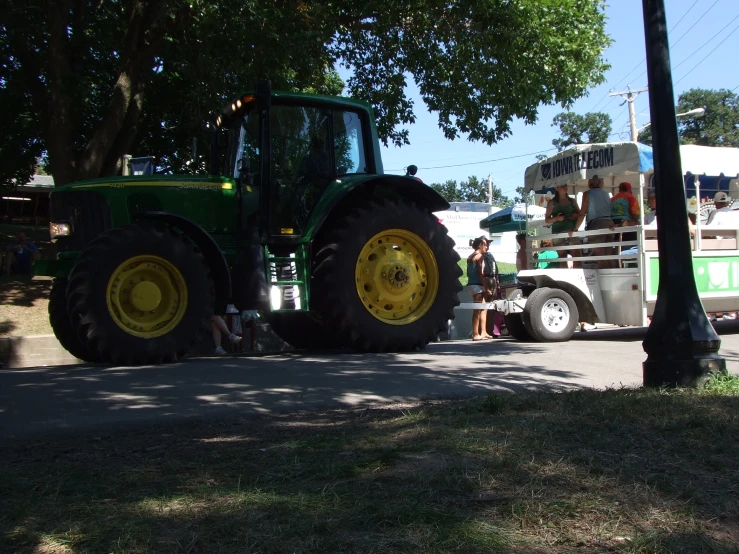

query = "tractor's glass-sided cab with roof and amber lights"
211;85;382;244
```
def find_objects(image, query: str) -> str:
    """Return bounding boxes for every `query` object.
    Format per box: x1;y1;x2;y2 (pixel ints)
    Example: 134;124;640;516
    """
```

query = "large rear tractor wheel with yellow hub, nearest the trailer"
311;200;462;352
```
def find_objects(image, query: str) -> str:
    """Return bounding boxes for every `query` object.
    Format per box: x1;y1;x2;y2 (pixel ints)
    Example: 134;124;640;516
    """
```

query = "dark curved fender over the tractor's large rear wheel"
305;175;449;240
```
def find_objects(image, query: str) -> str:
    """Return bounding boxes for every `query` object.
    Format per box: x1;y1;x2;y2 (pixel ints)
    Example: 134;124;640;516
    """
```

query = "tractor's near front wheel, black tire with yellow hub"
67;225;215;365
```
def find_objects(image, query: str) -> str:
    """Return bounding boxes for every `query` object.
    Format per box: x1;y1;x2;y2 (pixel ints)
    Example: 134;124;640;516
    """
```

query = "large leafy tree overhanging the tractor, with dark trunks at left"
0;0;609;184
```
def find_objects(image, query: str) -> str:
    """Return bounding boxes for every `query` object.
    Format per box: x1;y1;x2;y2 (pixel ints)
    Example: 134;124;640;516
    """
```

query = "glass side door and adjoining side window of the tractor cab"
268;101;371;240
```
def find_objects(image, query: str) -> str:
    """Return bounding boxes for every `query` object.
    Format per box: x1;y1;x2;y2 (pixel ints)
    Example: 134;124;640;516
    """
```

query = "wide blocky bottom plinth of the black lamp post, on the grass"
642;355;726;387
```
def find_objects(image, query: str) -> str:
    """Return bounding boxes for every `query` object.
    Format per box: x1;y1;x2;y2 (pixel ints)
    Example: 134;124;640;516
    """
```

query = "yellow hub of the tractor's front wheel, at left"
106;255;187;338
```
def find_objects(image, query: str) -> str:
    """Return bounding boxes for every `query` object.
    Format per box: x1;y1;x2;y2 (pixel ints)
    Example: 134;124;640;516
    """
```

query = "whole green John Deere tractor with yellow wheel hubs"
35;78;461;365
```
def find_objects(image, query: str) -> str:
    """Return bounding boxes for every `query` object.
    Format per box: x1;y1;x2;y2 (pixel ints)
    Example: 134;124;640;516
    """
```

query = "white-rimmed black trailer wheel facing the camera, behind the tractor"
522;287;580;342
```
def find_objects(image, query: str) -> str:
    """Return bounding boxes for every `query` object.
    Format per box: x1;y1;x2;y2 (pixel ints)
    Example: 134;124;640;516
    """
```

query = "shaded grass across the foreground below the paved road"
0;377;739;554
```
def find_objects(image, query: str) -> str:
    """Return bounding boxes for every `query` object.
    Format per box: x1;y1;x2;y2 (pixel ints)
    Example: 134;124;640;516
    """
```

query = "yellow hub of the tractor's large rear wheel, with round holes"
355;229;439;325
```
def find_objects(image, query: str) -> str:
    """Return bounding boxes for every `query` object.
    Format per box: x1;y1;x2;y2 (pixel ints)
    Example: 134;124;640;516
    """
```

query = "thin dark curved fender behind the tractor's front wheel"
135;212;231;314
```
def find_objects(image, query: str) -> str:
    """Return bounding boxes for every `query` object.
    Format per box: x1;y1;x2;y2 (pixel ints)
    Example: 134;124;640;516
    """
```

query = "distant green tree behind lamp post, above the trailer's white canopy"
639;89;739;148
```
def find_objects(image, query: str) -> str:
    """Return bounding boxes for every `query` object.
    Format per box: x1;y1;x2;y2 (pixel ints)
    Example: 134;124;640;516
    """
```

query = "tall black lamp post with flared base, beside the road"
642;0;726;386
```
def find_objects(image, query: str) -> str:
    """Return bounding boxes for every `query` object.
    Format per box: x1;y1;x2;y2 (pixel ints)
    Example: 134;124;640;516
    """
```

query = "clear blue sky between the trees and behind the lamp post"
362;0;739;196
